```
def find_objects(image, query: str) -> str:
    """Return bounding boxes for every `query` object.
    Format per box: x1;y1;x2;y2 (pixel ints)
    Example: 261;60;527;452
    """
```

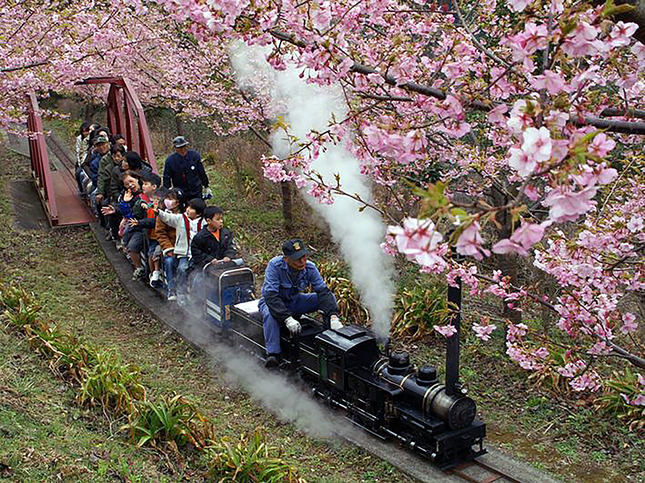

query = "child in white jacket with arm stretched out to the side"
158;198;206;305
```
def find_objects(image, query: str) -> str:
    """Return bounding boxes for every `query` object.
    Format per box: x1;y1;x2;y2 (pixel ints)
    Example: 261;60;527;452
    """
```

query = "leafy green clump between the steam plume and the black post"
391;283;450;340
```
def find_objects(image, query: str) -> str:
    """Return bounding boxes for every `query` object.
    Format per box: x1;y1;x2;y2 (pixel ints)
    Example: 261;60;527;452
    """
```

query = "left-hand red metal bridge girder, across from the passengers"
27;91;58;226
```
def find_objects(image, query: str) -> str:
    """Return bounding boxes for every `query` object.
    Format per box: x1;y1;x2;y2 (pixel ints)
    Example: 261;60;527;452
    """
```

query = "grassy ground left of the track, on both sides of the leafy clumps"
0;141;406;481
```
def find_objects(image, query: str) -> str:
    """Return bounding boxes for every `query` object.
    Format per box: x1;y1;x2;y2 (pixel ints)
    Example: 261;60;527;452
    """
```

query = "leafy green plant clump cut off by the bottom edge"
207;429;302;482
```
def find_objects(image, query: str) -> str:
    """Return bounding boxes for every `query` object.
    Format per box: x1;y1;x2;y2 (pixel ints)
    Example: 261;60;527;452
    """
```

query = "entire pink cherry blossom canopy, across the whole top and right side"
0;0;645;404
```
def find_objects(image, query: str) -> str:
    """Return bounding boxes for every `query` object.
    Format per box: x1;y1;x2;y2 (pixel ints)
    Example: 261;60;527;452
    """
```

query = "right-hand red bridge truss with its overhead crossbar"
76;77;157;173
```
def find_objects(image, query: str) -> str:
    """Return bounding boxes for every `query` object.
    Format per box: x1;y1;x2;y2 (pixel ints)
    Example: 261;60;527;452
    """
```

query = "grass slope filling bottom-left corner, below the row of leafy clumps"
0;331;179;481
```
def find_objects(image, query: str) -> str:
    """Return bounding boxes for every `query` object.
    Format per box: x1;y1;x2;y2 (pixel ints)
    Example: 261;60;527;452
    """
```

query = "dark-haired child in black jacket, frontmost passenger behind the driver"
190;206;237;271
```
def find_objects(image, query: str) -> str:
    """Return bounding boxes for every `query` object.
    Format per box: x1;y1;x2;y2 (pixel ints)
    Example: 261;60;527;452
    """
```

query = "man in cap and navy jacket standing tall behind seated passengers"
163;136;208;200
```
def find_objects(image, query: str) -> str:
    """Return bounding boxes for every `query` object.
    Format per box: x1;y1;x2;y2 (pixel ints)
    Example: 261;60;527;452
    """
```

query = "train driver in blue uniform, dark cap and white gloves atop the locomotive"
258;239;343;367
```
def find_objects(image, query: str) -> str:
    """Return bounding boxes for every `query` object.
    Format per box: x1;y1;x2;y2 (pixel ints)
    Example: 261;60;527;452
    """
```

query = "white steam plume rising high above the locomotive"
231;42;394;337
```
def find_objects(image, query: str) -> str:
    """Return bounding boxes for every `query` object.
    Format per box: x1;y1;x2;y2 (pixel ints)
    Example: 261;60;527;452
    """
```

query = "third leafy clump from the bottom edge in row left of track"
78;351;146;419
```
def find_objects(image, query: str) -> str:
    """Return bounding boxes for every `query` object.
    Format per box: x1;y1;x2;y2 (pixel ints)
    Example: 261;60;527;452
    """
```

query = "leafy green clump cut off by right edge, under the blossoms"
594;368;645;431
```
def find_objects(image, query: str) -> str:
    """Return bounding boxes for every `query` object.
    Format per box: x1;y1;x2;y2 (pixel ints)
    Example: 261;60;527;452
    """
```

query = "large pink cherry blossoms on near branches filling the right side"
138;0;645;398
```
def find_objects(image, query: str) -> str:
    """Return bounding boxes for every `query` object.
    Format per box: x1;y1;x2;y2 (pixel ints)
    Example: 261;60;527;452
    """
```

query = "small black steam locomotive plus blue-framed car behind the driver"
204;263;486;469
